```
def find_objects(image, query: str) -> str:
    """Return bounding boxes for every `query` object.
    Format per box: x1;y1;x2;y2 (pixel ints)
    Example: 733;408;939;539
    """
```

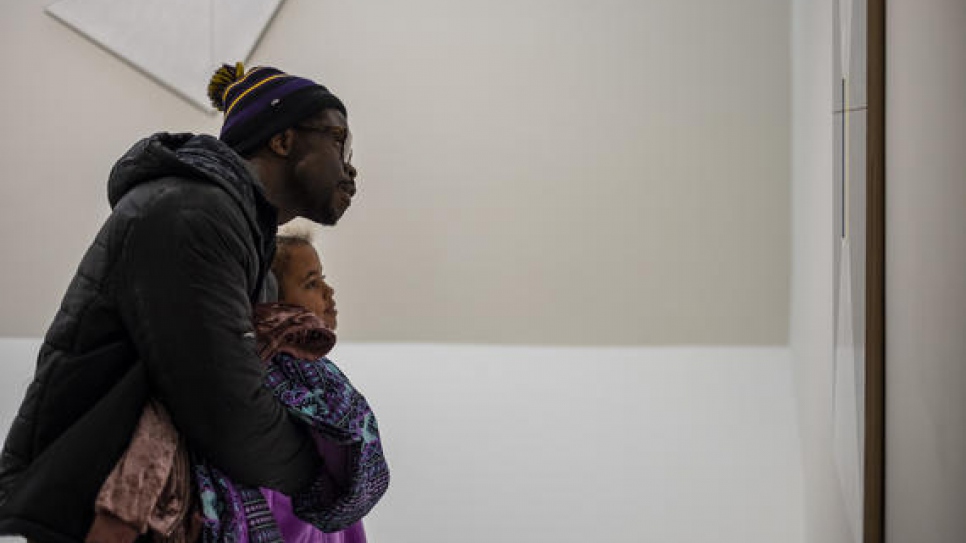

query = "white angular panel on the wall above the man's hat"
46;0;283;111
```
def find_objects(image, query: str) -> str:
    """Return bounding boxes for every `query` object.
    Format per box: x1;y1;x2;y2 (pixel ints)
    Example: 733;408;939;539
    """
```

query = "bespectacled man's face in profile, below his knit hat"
287;109;356;225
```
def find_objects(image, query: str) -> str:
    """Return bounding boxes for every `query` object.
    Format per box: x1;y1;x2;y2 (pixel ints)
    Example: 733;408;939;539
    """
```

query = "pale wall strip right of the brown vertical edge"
885;0;966;543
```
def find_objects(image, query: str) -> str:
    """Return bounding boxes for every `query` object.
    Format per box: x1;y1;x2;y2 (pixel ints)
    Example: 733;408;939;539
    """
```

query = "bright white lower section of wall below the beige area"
0;340;802;543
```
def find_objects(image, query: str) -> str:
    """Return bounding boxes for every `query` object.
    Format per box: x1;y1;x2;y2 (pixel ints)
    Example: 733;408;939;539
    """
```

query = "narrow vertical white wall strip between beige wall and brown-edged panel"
790;0;855;543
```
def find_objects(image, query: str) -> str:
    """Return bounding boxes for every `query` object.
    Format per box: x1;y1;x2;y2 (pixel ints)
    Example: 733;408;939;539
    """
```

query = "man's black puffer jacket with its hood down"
0;134;318;543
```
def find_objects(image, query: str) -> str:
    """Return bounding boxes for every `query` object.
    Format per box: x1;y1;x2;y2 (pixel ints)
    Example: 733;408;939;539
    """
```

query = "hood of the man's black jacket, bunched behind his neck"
107;132;278;260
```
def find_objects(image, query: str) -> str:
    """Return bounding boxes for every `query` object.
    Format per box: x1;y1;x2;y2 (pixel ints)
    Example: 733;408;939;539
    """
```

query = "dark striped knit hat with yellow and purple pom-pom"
208;62;346;156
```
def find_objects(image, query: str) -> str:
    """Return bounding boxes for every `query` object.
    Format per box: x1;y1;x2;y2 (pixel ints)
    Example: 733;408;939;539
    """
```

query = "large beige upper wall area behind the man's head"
0;0;790;345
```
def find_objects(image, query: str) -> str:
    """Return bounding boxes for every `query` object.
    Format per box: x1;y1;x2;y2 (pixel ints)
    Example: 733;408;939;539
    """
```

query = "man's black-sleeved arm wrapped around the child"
115;189;320;494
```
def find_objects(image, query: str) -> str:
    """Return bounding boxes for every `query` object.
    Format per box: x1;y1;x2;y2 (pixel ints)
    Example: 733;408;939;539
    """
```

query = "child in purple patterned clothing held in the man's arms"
87;223;388;543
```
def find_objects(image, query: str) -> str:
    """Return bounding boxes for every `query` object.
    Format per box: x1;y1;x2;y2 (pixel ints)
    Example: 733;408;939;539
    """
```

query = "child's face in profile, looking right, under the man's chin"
279;243;338;330
